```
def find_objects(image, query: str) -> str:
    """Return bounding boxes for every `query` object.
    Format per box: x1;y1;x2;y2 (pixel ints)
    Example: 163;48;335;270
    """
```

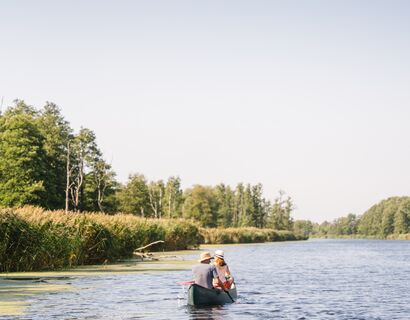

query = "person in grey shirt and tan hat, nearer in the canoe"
192;252;223;289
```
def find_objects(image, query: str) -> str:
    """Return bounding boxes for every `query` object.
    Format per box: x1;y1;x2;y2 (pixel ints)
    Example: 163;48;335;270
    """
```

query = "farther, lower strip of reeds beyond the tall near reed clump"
200;227;307;244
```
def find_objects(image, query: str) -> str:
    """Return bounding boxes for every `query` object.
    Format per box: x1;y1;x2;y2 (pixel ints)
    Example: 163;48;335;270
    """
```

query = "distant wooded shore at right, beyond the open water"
294;197;410;238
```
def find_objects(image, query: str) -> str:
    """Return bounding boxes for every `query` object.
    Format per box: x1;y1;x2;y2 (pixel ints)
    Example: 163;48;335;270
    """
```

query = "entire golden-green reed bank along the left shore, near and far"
0;207;304;272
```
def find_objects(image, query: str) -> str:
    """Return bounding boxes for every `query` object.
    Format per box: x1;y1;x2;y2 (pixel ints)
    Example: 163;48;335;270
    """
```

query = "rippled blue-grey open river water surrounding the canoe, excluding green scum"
4;240;410;320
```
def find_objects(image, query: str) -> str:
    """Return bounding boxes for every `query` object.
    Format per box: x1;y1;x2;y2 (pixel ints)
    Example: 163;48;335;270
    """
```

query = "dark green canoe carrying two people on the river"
188;284;237;306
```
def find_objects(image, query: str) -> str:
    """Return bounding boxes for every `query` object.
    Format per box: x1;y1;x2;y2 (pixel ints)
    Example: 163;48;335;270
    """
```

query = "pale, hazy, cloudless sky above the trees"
0;0;410;222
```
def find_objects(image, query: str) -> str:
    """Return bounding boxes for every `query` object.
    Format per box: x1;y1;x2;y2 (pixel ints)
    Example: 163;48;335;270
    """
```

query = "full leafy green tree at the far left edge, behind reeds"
0;100;47;207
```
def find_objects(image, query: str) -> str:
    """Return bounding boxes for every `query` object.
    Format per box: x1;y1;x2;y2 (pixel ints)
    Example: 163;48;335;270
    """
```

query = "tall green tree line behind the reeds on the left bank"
0;100;294;230
